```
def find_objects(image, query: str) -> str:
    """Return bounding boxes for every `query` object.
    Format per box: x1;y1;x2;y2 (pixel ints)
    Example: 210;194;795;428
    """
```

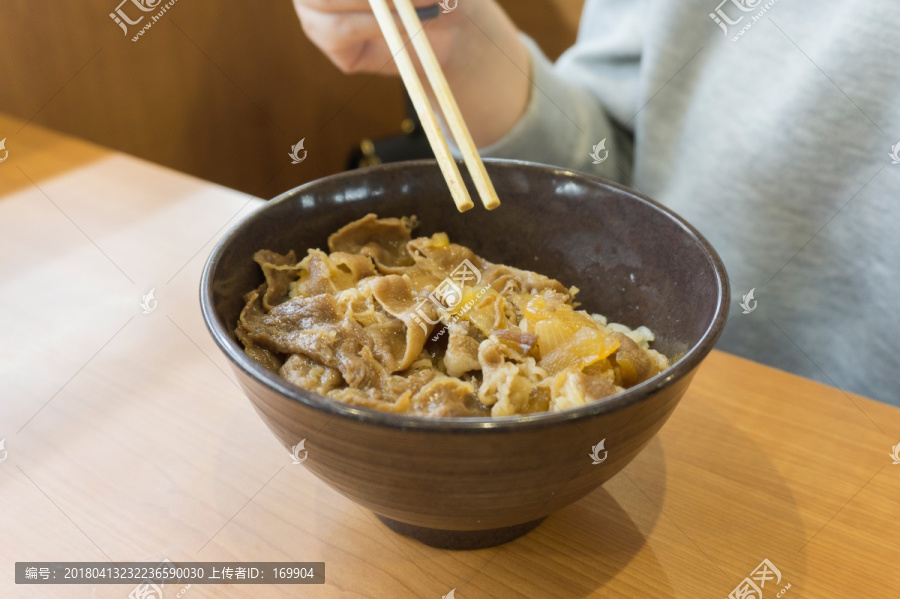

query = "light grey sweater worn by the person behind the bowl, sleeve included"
484;0;900;408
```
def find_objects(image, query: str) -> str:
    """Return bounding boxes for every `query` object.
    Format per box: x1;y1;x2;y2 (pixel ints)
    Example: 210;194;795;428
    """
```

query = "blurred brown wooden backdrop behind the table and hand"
0;0;583;198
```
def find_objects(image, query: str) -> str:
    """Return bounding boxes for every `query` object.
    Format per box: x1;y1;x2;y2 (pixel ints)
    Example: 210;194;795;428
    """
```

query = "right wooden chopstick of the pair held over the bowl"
394;0;500;210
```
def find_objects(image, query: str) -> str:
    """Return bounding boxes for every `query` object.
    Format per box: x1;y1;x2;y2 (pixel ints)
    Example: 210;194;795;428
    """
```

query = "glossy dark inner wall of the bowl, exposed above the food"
201;161;727;422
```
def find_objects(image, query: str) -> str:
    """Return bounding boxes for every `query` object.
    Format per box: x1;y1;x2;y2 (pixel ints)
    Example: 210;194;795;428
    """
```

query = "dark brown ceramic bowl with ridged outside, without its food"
200;161;729;547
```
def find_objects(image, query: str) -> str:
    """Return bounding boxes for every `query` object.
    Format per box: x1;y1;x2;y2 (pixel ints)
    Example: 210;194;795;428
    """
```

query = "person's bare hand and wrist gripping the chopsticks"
294;0;531;146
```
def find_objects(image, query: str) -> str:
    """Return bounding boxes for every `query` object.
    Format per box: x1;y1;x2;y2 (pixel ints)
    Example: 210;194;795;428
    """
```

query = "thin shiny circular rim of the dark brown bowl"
199;158;730;433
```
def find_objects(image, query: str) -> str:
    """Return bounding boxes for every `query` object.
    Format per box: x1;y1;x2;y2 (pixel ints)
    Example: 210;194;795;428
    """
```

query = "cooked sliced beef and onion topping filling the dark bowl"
235;214;669;417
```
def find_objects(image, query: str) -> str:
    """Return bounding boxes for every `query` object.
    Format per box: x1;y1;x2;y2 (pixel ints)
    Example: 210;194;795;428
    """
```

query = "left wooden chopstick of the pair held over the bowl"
369;0;475;212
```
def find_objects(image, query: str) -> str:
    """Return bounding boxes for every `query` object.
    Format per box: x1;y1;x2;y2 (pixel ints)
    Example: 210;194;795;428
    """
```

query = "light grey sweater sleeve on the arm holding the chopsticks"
468;0;642;184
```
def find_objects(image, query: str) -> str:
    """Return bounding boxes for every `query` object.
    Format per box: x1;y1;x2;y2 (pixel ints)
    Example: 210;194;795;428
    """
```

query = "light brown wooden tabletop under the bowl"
0;117;900;599
